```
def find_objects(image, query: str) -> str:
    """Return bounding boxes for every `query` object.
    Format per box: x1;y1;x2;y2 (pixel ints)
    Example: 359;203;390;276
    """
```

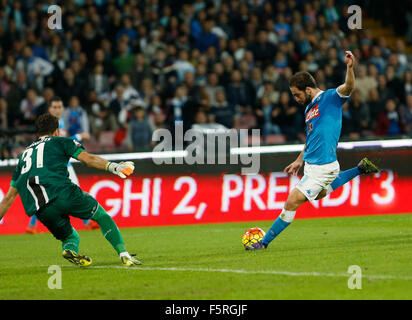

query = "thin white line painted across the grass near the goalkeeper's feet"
57;265;412;280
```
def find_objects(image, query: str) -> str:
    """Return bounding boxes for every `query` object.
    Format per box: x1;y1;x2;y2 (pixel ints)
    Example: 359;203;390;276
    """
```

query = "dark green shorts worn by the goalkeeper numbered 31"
36;185;99;240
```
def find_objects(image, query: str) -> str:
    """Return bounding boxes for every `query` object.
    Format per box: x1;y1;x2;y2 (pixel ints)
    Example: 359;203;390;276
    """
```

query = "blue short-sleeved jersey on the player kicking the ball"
303;89;349;165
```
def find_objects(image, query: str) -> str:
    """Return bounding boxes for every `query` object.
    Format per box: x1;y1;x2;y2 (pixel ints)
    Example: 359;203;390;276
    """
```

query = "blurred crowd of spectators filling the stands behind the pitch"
0;0;412;157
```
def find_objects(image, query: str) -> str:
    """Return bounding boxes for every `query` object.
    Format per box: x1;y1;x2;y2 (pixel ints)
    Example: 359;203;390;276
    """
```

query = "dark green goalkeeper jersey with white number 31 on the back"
11;136;84;216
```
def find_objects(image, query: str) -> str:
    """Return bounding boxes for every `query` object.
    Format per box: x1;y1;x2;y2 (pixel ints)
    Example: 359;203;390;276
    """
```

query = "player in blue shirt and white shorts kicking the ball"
246;51;379;250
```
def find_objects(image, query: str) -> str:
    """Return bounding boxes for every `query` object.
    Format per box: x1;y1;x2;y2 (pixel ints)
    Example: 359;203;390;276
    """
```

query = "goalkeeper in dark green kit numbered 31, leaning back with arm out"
0;113;141;267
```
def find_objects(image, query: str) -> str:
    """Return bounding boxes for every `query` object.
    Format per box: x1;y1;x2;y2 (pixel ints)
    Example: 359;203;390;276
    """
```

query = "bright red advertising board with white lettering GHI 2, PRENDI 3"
0;171;412;234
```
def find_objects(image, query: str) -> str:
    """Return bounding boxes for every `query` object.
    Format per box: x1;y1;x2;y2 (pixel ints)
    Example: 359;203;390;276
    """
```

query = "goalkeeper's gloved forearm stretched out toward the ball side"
77;151;134;179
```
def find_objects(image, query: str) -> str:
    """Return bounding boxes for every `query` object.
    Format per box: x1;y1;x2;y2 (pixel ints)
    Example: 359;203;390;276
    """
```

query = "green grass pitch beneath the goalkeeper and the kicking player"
0;214;412;300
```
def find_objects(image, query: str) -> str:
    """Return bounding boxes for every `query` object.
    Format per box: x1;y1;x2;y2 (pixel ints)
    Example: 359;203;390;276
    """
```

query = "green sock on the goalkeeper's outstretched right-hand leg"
91;205;126;254
